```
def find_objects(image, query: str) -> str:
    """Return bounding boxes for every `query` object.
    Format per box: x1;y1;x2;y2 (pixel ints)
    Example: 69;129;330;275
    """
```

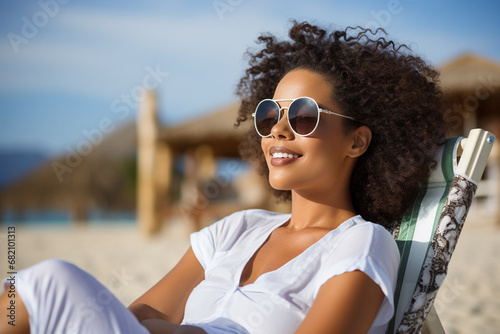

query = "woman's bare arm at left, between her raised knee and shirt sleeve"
128;248;205;324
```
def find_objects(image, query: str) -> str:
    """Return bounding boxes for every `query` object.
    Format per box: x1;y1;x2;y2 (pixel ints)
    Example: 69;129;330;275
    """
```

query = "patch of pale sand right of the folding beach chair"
434;220;500;334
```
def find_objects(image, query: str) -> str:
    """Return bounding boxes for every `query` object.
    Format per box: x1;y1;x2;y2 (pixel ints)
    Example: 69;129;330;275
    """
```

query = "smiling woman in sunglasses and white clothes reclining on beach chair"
1;23;444;334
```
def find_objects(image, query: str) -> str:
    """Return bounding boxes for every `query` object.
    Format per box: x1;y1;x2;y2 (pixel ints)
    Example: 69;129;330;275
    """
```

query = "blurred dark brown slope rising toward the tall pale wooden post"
0;124;136;220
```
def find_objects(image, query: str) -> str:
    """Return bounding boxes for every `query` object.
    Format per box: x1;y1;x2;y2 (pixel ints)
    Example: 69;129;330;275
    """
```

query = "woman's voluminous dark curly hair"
236;21;445;228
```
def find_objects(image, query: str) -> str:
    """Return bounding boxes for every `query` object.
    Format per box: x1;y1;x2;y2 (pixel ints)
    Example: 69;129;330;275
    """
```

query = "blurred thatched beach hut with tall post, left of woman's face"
137;88;283;234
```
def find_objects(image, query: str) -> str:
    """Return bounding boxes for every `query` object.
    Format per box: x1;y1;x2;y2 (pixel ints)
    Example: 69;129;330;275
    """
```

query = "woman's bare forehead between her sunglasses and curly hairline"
273;69;333;103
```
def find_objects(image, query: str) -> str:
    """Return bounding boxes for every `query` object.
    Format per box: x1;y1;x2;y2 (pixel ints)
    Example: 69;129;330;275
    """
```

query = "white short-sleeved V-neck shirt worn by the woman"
183;210;399;334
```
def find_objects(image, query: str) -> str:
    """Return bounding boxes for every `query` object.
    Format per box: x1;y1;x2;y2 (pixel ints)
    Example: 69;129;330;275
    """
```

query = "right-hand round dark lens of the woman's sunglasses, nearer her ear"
288;98;319;136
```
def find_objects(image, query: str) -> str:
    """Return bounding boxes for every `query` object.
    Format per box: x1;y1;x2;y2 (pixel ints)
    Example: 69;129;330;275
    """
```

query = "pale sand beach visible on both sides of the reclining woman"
0;215;500;334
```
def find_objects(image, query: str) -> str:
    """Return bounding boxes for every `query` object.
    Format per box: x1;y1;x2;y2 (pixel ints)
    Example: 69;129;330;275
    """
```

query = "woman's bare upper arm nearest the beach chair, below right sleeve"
295;271;384;334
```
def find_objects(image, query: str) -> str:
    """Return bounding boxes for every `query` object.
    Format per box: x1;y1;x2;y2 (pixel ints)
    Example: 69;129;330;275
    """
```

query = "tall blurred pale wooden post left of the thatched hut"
137;91;160;236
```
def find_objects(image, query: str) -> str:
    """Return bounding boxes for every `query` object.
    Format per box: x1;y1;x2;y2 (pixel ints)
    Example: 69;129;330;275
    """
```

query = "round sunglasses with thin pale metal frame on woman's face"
252;97;356;137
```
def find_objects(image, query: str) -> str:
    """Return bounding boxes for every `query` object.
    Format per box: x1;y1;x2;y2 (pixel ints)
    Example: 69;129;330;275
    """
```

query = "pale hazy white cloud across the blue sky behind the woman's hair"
0;0;498;115
